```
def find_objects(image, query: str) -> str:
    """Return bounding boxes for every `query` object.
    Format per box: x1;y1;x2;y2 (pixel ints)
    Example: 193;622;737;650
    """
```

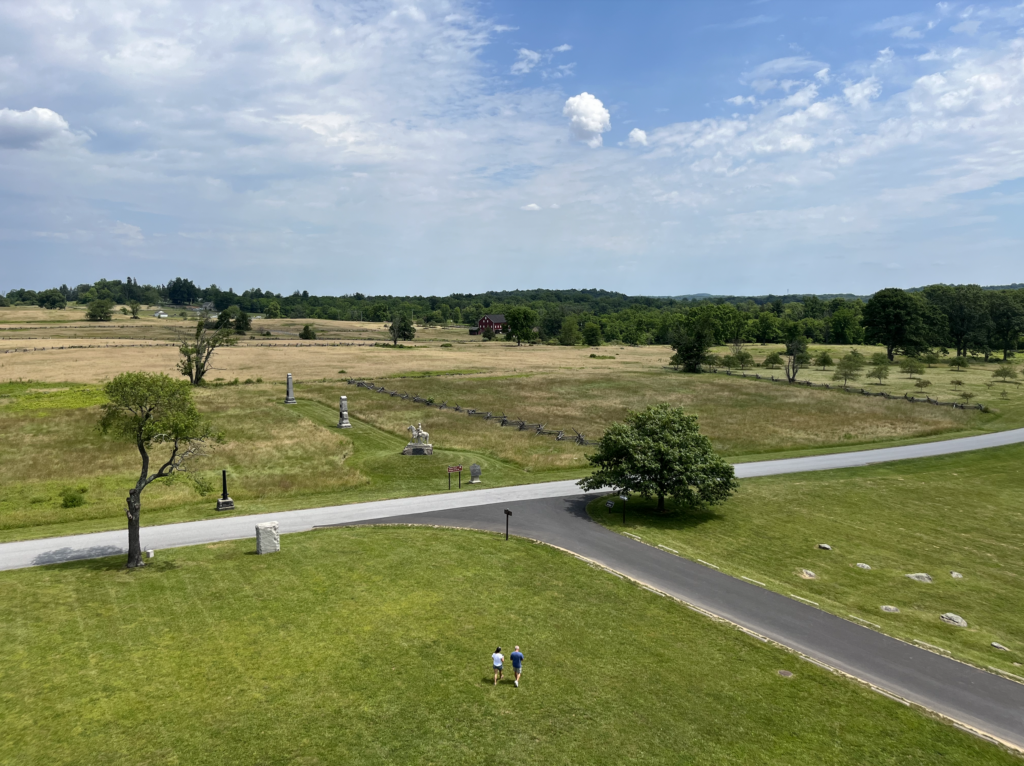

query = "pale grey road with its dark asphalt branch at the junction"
0;429;1024;750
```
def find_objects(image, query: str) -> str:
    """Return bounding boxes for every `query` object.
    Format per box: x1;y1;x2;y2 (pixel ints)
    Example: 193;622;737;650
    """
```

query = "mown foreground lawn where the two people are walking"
0;527;1007;766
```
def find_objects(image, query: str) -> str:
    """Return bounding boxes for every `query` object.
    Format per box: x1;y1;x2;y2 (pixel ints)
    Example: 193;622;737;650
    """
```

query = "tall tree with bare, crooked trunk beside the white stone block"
99;373;213;568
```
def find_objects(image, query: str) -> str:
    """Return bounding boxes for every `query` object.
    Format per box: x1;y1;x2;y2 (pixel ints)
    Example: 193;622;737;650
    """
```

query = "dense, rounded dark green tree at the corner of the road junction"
580;405;737;511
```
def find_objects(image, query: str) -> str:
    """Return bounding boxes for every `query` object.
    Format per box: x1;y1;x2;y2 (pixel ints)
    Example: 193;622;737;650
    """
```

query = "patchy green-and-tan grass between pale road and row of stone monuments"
0;384;579;542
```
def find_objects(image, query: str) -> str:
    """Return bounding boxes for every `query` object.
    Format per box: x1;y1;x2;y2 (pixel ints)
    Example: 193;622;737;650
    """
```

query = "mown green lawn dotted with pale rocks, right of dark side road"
590;445;1024;676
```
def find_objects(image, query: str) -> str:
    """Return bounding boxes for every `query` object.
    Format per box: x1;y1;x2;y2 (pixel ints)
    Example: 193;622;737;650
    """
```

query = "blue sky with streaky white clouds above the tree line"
0;0;1024;295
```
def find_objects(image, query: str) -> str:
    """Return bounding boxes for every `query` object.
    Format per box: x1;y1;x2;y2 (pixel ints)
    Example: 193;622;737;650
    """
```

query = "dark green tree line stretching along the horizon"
0;278;1024;356
